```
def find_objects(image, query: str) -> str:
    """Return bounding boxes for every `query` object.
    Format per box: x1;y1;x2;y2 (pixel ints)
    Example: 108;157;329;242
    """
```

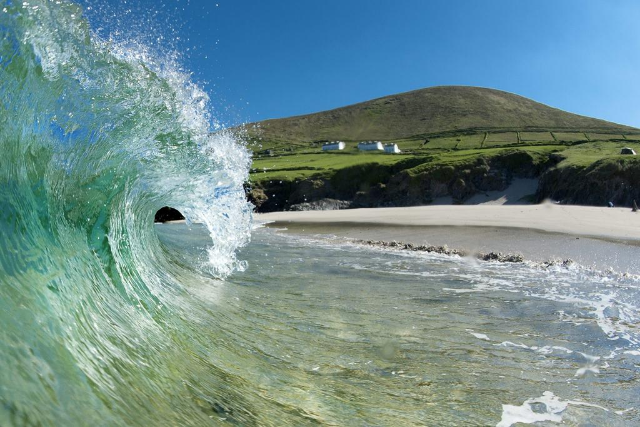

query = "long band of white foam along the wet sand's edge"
286;232;640;349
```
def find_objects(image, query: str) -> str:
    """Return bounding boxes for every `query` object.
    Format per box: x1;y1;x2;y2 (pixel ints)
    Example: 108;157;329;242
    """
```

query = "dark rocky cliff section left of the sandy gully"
247;150;561;212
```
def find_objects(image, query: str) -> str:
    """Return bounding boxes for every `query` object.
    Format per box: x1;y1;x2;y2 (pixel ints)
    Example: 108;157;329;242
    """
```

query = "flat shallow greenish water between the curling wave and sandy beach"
157;225;640;425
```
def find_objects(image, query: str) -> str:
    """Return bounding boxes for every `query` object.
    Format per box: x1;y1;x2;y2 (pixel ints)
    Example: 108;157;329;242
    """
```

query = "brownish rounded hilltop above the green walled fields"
248;86;638;143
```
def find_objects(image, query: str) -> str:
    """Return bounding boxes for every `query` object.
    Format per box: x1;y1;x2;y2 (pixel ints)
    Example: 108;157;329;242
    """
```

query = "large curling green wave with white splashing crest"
0;1;255;426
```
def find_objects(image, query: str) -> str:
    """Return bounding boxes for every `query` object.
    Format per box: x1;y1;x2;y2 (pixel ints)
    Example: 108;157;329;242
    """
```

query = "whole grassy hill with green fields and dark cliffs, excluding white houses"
243;86;640;211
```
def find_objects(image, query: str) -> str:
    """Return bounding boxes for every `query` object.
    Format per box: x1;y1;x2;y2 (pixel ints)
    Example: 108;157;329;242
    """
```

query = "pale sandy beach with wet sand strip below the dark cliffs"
257;204;640;274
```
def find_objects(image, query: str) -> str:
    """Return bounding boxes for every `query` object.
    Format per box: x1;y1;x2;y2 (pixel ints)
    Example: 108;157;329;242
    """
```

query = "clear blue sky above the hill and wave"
83;0;640;127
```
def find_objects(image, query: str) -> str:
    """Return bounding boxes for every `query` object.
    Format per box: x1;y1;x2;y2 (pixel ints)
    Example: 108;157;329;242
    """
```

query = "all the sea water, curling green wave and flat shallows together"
0;0;640;427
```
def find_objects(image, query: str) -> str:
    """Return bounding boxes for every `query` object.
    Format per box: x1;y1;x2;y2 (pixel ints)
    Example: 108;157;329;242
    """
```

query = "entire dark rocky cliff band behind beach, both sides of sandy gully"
247;149;640;212
